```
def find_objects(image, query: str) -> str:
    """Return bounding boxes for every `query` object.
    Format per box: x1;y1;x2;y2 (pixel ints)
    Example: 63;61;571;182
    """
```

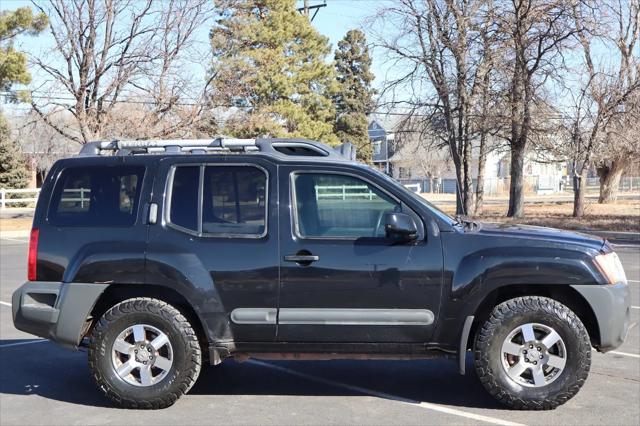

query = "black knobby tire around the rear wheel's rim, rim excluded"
88;297;202;409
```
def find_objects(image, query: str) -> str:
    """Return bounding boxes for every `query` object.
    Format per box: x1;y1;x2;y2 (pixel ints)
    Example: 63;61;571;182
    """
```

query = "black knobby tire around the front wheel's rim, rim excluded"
474;296;591;410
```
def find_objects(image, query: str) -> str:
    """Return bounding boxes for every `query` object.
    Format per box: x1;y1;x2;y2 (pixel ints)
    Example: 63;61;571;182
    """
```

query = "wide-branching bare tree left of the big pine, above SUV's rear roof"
32;0;211;143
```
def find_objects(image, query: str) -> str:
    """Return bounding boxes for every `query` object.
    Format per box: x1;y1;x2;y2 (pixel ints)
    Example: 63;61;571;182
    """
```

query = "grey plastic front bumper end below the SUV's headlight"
571;283;631;352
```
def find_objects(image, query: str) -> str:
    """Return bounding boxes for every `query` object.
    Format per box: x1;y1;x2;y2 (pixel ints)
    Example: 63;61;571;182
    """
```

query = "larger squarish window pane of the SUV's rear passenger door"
202;166;267;235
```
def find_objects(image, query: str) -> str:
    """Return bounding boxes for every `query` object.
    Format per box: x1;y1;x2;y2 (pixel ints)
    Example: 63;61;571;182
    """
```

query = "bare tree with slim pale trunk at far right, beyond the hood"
567;2;640;217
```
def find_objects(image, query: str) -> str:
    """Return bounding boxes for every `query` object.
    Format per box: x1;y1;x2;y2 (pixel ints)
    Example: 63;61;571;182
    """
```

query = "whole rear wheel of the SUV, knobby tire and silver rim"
89;298;202;408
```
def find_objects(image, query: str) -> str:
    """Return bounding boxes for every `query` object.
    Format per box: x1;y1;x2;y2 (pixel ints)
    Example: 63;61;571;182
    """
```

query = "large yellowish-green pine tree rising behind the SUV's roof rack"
211;0;338;145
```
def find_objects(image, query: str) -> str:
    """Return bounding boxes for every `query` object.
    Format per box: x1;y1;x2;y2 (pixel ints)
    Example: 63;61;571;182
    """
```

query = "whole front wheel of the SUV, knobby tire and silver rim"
474;296;591;410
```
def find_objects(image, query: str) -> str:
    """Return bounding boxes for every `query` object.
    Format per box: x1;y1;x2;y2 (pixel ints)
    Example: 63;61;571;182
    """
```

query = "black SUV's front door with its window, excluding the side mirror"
278;165;442;343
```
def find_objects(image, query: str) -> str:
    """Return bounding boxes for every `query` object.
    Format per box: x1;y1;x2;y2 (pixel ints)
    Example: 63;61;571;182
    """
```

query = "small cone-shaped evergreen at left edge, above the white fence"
0;114;29;189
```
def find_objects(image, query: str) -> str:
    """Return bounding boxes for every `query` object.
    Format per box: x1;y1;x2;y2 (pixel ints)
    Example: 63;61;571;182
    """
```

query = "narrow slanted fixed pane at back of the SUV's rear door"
169;166;200;232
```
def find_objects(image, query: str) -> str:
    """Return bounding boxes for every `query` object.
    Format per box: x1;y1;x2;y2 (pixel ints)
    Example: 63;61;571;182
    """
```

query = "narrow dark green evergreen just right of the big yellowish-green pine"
335;30;375;163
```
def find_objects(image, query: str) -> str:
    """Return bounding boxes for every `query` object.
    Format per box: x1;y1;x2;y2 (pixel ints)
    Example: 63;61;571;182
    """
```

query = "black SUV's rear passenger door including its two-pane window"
147;155;279;345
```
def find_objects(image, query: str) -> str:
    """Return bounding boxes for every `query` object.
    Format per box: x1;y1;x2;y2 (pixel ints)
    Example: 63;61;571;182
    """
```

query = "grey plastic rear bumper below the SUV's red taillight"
11;281;109;349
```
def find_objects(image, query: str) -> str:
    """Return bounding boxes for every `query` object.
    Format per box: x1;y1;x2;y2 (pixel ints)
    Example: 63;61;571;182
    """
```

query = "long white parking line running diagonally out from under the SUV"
247;359;524;426
